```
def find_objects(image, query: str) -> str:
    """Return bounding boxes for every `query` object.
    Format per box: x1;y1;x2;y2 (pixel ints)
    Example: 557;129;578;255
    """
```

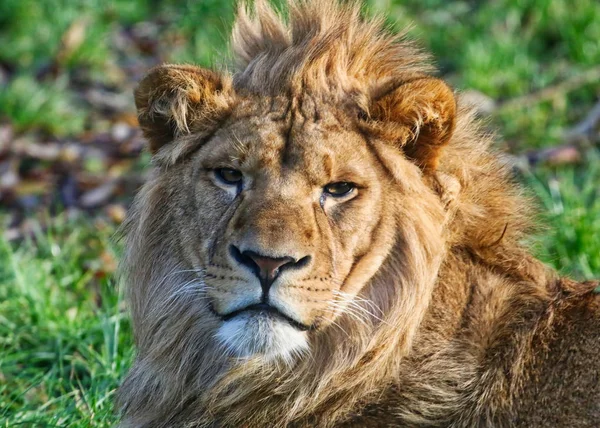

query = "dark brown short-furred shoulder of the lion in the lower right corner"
515;281;600;427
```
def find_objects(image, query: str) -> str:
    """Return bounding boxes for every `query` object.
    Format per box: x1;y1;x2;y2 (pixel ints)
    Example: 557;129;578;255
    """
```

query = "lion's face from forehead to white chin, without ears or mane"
165;100;394;357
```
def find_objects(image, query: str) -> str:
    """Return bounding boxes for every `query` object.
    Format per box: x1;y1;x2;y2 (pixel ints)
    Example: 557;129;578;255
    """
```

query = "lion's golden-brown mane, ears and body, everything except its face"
118;0;600;427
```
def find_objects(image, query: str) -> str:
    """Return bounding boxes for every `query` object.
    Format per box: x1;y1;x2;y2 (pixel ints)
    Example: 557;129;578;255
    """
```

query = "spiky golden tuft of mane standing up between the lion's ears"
231;0;432;100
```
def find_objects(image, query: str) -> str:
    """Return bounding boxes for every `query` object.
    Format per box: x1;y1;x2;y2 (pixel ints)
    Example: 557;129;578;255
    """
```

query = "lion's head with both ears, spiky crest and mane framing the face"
115;0;516;426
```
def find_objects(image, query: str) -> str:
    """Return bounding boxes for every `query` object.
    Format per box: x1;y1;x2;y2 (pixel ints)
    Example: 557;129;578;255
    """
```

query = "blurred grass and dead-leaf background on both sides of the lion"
0;0;600;427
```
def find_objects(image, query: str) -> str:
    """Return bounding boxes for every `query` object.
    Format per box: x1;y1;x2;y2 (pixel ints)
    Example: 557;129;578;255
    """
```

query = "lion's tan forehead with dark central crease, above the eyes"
212;110;377;184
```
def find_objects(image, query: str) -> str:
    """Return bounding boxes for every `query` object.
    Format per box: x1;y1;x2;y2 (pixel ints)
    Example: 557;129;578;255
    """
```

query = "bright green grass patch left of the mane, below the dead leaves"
0;220;133;427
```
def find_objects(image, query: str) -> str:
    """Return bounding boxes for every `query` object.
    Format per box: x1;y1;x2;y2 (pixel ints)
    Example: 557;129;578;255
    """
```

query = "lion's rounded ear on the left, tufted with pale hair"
134;64;233;154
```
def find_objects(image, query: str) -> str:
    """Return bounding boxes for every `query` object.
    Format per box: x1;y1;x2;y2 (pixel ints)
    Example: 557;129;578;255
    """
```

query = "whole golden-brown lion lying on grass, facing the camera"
118;0;600;427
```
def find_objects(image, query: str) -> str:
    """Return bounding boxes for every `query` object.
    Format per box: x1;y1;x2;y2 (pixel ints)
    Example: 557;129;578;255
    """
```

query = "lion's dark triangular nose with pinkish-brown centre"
231;245;310;297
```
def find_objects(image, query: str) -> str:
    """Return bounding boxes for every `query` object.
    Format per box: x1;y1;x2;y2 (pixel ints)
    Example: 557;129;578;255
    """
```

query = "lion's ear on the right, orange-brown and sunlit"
369;77;456;171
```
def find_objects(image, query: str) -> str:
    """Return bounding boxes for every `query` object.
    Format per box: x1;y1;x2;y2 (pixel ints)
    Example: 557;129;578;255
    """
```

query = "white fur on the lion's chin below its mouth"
215;314;308;363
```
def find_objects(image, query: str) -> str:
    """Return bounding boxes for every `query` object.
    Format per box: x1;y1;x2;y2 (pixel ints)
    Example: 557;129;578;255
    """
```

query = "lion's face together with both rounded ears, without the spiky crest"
129;61;454;361
